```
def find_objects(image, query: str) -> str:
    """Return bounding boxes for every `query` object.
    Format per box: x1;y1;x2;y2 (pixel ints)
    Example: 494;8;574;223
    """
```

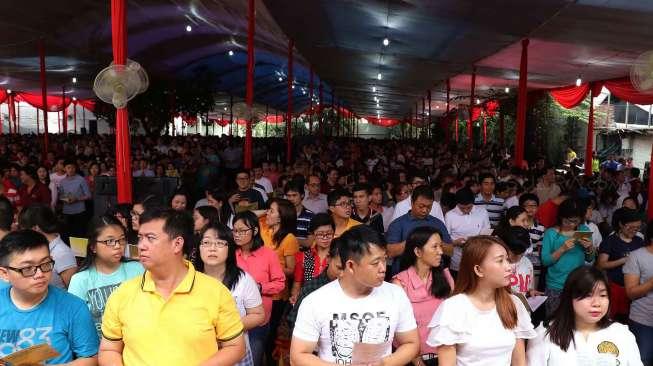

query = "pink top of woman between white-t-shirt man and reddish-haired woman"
393;266;453;355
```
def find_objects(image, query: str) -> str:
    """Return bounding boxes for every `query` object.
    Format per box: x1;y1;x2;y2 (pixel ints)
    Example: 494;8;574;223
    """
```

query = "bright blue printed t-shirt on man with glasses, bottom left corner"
0;285;100;364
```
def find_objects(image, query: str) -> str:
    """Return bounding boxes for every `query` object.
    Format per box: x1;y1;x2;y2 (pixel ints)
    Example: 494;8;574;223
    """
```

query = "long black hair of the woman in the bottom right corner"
547;266;612;352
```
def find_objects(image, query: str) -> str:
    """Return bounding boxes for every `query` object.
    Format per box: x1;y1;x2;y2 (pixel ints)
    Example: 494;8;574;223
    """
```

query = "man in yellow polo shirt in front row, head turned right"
98;209;245;366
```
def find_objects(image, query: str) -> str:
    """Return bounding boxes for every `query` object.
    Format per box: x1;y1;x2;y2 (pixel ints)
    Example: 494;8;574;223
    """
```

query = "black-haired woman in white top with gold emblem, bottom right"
527;266;642;366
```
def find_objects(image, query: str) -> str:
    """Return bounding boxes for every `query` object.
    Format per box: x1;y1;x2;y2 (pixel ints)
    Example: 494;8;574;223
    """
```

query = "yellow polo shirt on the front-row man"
102;262;243;366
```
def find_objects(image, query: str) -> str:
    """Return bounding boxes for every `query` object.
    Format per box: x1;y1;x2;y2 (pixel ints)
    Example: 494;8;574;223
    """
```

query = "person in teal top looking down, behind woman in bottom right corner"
542;198;596;318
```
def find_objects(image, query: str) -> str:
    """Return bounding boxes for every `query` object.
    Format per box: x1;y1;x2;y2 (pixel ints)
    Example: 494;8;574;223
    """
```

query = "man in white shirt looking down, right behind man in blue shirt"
444;188;491;273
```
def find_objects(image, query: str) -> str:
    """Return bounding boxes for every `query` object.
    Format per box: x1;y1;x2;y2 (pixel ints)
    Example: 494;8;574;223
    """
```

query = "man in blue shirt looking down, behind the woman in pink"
386;185;452;275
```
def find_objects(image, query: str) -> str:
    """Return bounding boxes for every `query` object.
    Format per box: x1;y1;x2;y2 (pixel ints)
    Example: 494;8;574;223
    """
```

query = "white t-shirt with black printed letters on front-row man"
293;281;417;364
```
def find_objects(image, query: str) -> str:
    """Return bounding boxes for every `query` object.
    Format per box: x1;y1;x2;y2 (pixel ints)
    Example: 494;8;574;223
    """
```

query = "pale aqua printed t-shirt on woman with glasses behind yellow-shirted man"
68;261;145;336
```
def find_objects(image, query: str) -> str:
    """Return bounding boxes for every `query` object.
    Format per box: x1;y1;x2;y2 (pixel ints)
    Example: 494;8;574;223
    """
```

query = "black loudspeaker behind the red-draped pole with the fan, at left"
93;177;179;216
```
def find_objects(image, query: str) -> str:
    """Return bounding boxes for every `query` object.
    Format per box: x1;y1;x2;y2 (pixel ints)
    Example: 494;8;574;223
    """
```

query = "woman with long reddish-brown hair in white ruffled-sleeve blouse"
426;236;536;366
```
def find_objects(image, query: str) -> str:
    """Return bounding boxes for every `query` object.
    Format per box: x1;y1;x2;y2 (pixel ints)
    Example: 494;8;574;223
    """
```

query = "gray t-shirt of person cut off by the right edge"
623;247;653;327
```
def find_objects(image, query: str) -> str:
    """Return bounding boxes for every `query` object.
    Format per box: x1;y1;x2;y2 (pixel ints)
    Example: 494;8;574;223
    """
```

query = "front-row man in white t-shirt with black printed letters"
290;225;419;366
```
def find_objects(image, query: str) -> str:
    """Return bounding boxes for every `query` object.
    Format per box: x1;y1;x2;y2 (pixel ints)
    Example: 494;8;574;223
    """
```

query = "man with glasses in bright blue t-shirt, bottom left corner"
0;230;99;366
